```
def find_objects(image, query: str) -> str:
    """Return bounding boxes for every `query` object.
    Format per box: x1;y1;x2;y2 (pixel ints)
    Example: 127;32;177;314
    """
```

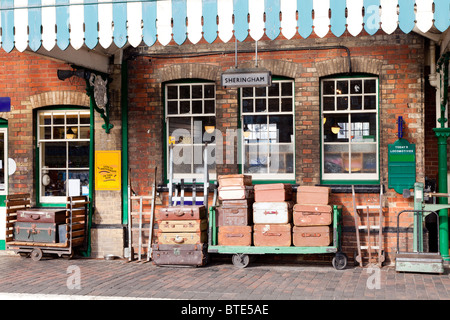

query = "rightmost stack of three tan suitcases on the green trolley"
292;187;333;247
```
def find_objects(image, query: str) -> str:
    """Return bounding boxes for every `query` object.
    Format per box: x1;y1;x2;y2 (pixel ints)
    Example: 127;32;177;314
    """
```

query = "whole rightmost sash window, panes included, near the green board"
321;78;379;182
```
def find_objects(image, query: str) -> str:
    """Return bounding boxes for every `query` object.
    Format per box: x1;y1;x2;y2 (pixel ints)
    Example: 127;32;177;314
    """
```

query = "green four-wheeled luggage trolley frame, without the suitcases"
208;205;348;270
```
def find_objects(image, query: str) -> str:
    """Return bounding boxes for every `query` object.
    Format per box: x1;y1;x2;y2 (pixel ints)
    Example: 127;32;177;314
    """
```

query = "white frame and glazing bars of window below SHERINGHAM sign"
240;79;295;181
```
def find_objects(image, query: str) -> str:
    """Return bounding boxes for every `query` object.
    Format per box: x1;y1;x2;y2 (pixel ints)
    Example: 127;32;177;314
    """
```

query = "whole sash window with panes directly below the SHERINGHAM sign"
240;80;295;180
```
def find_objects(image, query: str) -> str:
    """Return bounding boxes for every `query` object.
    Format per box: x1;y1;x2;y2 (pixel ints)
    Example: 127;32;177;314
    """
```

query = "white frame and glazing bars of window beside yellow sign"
37;109;93;204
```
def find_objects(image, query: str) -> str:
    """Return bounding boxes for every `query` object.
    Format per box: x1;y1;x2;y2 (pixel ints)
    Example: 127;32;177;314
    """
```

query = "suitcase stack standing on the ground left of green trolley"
152;205;208;266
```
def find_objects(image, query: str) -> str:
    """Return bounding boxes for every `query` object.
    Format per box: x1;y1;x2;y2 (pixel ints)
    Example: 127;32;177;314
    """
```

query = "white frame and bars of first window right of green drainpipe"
164;81;217;182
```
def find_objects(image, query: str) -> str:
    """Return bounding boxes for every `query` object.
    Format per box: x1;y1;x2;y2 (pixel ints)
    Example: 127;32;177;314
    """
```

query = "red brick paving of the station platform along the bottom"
0;255;450;301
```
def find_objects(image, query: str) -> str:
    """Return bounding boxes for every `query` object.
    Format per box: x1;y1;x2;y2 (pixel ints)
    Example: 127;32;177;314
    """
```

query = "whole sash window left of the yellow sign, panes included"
38;110;90;203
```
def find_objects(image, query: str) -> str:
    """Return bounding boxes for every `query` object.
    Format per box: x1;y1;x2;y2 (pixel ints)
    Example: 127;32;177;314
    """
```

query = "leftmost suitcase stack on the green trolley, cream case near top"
216;174;254;246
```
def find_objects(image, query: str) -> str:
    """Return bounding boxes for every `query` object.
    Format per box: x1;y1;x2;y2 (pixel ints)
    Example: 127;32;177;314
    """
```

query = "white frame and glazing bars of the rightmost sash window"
320;76;380;182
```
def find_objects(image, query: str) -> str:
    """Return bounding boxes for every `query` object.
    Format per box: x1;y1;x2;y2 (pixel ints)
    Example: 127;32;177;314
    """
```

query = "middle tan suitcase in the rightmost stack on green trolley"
293;204;333;227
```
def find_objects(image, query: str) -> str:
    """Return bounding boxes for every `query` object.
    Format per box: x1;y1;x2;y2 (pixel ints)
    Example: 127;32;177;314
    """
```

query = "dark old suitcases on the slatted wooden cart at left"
14;208;67;243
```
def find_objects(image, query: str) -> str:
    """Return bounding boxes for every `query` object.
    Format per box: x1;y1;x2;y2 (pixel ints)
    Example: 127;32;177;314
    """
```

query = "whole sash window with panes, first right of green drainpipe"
165;83;217;181
